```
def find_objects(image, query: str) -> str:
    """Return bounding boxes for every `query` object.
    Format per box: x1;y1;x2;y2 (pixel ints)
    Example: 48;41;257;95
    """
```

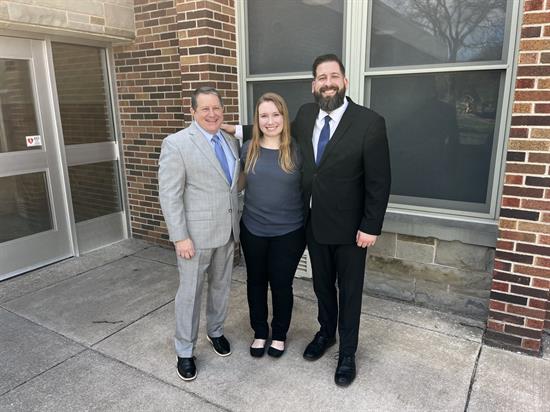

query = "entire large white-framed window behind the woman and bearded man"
239;0;519;222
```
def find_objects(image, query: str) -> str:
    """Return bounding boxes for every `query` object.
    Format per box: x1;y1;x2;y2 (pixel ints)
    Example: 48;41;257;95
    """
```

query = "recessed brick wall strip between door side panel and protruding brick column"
114;0;185;244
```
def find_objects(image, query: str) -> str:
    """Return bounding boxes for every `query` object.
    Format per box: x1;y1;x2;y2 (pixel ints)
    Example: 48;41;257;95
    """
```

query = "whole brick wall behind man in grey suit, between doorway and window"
114;0;238;244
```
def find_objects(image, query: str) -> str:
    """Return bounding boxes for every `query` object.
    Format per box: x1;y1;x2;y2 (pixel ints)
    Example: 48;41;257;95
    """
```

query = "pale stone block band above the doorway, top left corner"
0;0;135;40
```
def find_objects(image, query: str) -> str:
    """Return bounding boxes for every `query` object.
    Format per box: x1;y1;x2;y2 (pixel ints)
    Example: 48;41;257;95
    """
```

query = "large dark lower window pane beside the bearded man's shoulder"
371;71;501;211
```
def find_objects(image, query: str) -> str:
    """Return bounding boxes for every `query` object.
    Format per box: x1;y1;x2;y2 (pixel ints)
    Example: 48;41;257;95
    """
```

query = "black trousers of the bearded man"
306;219;367;356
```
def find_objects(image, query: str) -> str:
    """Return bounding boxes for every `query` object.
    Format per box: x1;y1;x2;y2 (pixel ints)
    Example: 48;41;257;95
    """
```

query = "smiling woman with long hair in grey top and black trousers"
240;93;305;357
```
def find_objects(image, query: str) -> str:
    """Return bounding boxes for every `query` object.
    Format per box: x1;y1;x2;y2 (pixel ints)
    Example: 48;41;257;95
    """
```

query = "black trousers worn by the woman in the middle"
240;221;306;341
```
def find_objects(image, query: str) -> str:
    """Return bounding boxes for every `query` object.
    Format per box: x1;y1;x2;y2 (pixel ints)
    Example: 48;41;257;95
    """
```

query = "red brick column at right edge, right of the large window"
485;0;550;353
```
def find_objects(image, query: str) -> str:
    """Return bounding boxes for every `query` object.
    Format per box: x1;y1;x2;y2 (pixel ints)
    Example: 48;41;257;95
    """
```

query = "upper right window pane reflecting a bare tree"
370;0;510;67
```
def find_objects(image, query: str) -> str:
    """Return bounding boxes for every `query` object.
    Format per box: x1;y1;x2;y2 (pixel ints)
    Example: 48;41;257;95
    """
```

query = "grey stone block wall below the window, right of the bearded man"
365;233;494;319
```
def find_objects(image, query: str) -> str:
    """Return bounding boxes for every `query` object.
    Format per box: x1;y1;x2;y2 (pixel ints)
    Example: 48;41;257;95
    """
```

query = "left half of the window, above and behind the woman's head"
243;0;346;119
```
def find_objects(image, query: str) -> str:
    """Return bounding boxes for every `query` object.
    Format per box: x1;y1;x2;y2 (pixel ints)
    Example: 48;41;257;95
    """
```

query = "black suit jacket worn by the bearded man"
245;98;391;244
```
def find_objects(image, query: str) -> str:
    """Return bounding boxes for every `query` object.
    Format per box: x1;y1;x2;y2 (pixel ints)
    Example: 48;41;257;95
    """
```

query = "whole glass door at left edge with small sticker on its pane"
0;37;74;280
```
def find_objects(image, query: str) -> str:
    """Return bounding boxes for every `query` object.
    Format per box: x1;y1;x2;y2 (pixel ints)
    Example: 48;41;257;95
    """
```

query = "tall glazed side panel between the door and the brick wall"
51;42;126;253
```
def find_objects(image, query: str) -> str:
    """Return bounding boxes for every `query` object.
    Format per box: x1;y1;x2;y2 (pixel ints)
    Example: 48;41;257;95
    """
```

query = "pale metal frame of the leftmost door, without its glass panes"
0;36;74;280
